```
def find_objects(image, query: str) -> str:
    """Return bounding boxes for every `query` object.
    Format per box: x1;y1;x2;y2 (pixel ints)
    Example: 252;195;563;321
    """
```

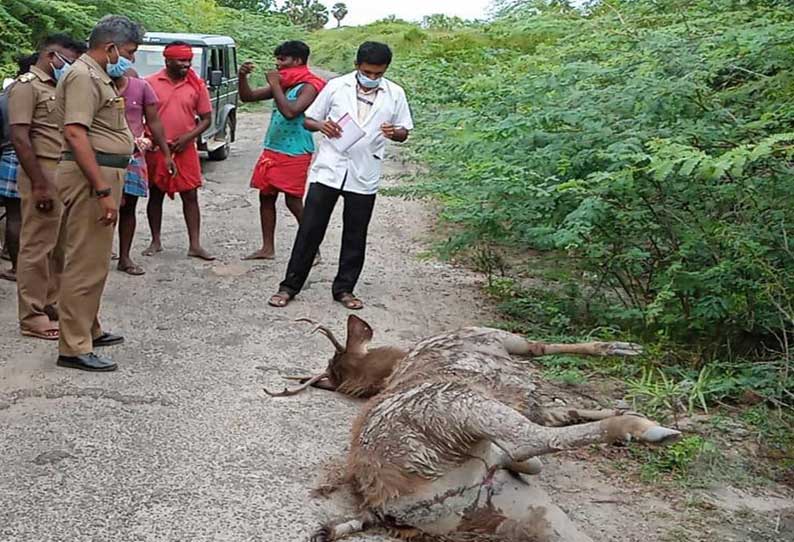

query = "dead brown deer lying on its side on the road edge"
276;316;677;542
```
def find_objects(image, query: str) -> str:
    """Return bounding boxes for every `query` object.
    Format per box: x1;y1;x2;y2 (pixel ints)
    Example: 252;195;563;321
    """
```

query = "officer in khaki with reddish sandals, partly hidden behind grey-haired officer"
8;34;85;340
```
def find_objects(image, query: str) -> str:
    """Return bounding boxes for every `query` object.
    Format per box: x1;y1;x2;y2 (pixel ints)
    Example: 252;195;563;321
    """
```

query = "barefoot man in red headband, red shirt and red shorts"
143;42;215;260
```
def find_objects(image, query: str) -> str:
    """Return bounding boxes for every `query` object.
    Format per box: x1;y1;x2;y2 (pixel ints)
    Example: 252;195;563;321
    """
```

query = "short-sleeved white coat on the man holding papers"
305;72;414;194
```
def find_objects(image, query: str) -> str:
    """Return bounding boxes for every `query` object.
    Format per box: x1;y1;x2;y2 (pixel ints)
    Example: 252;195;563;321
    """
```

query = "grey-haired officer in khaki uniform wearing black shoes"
55;15;143;371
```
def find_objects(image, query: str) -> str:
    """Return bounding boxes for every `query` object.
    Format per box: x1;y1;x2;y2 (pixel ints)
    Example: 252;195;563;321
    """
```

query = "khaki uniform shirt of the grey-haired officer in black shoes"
55;54;134;154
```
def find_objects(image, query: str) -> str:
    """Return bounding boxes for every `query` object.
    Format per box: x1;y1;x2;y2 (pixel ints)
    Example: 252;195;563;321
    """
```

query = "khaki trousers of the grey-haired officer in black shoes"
56;160;125;356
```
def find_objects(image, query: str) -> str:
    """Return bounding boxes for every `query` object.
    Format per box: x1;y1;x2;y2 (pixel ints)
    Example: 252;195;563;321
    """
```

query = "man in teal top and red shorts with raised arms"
239;41;325;260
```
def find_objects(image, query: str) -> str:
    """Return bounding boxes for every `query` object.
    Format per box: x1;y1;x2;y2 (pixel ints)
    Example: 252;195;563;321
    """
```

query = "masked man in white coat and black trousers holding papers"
268;42;413;310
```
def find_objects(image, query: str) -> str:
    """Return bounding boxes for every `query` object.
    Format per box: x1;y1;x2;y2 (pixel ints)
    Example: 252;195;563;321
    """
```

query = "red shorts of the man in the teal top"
251;149;312;198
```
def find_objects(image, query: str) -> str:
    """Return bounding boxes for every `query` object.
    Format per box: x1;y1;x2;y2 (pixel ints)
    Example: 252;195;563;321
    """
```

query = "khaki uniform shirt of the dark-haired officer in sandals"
8;66;63;159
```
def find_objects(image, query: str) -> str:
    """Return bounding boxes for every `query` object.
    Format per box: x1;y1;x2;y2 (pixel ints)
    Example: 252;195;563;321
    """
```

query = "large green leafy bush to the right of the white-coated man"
314;0;794;357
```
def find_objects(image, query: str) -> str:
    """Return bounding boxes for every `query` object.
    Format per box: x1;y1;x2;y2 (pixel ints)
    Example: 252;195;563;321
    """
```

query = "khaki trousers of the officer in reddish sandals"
17;158;64;331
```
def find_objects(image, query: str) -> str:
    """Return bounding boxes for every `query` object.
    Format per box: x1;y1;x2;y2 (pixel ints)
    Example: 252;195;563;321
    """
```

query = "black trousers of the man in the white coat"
279;183;375;299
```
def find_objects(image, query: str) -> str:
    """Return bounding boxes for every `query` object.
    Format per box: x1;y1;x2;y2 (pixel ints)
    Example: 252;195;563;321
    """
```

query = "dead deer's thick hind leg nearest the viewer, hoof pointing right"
466;397;681;462
